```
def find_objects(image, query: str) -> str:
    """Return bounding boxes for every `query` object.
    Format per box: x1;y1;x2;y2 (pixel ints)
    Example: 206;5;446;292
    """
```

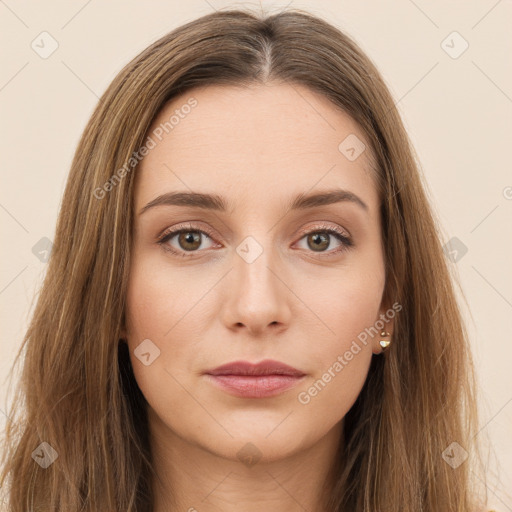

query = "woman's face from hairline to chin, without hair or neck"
125;85;392;460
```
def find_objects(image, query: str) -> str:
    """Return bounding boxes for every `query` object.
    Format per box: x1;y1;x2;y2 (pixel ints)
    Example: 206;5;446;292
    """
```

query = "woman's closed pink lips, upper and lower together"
205;359;306;398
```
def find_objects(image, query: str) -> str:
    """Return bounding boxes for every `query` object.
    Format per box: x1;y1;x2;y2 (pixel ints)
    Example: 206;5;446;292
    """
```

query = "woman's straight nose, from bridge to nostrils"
221;239;293;336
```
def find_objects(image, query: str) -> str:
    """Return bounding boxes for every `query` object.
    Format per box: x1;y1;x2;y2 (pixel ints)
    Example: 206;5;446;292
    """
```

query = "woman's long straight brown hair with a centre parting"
2;9;488;512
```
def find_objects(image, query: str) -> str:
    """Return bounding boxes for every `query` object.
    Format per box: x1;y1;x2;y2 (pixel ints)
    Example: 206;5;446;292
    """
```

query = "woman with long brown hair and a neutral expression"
2;6;492;512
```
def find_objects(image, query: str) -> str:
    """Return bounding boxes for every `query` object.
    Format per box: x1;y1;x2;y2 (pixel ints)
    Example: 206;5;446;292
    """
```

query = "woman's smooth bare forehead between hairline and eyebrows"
136;84;377;212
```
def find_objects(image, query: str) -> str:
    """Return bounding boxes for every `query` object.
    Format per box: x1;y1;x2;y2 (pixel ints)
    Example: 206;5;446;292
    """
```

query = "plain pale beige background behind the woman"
0;0;512;511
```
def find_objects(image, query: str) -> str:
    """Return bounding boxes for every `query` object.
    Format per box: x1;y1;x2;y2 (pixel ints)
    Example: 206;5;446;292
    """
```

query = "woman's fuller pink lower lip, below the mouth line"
207;374;303;398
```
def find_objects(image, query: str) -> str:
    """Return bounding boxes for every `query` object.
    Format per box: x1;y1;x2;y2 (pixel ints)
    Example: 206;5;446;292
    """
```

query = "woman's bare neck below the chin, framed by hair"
148;408;342;512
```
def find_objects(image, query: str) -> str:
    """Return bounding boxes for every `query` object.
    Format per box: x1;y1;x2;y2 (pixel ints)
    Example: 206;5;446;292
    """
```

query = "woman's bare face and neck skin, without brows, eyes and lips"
125;84;393;512
